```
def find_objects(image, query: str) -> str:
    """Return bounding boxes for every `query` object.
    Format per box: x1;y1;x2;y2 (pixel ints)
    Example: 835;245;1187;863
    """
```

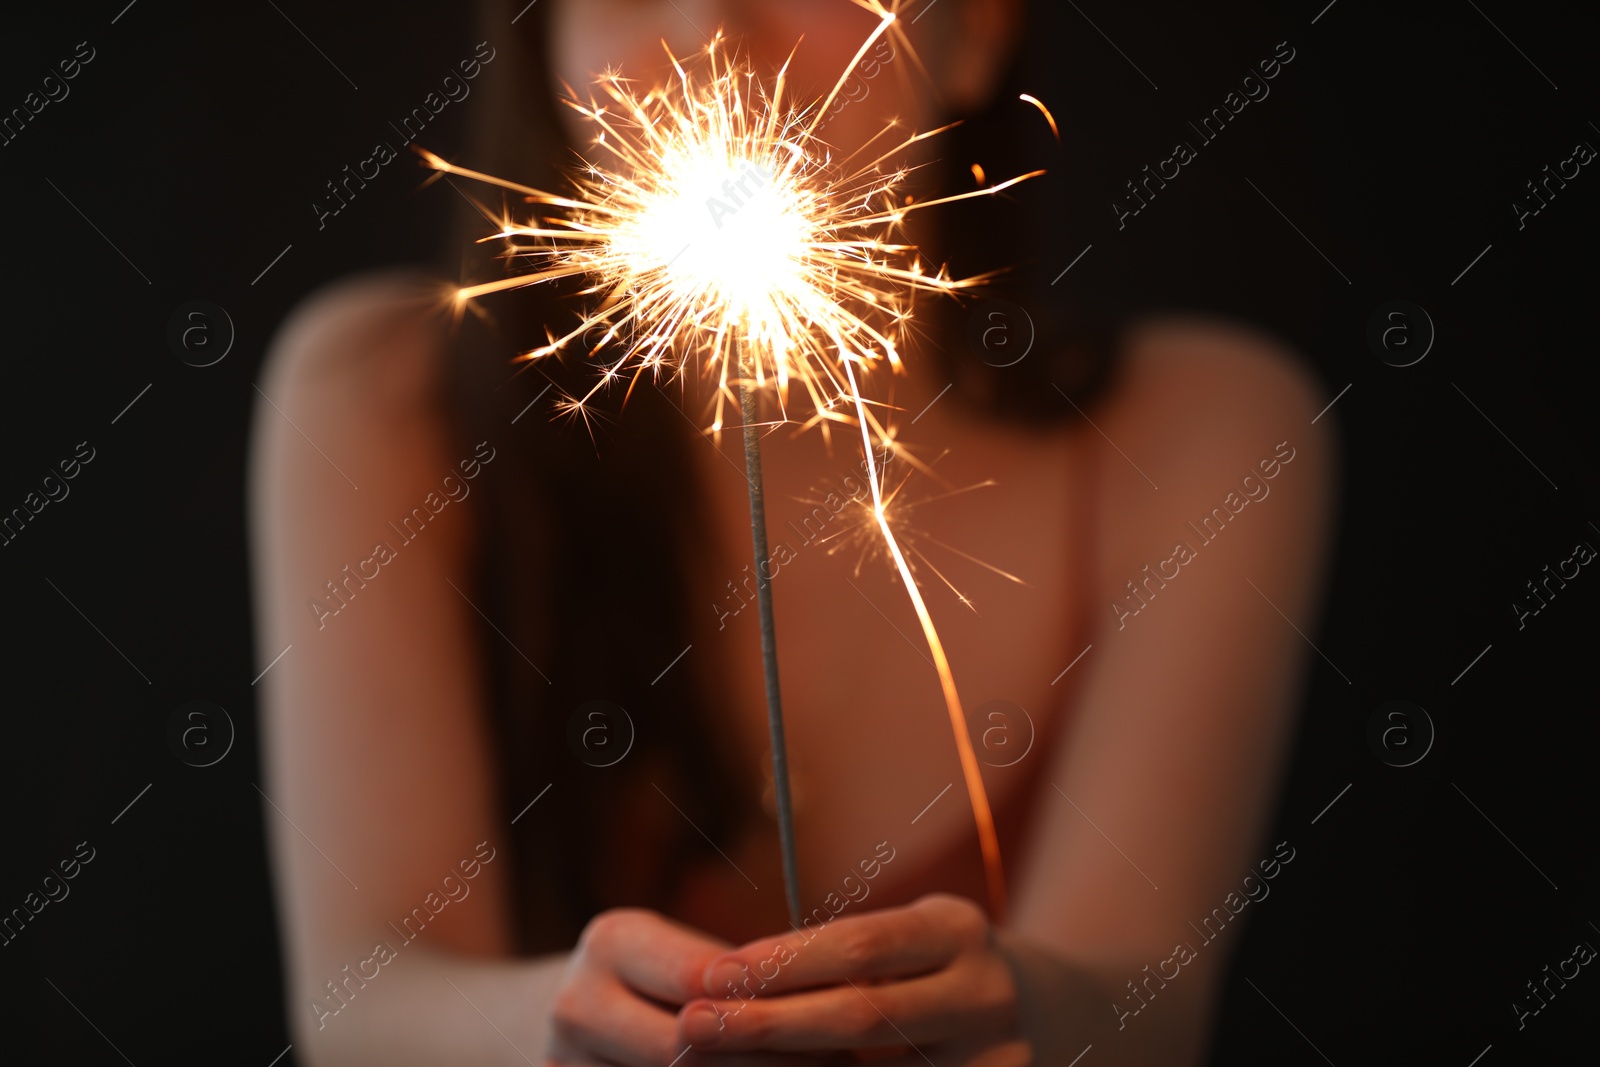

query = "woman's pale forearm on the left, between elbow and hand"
288;945;568;1067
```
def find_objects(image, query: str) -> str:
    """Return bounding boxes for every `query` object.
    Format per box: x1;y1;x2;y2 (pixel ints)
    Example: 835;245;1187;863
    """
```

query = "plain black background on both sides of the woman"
0;0;1600;1067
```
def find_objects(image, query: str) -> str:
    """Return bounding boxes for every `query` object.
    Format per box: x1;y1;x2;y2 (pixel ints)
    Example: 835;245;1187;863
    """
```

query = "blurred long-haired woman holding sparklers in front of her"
253;0;1334;1067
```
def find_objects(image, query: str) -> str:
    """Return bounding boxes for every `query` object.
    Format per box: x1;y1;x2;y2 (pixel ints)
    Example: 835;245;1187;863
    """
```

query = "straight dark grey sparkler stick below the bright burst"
739;348;800;929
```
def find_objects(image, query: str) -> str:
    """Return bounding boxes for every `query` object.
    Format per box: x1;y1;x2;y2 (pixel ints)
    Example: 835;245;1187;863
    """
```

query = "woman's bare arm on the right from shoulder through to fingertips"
680;322;1334;1067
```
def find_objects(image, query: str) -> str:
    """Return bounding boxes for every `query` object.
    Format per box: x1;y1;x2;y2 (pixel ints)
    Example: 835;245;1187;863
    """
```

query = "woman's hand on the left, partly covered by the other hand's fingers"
541;909;818;1067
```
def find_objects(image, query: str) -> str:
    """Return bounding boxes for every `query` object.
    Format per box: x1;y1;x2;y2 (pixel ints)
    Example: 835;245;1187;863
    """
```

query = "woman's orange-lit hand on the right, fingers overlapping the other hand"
677;893;1034;1067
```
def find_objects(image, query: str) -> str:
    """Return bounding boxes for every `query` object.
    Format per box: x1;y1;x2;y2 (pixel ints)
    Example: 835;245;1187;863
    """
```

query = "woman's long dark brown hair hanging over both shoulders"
446;0;1114;953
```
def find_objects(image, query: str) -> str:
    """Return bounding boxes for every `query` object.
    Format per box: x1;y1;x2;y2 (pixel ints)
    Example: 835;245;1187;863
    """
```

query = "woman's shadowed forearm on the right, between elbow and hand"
998;931;1211;1067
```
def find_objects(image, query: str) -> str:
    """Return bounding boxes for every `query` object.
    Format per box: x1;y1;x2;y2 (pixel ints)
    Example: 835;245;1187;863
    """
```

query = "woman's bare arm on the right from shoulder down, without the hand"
1011;320;1336;1065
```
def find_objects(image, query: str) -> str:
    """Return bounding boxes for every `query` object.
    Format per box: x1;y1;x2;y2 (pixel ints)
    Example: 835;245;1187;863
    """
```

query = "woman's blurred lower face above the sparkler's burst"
552;0;1016;150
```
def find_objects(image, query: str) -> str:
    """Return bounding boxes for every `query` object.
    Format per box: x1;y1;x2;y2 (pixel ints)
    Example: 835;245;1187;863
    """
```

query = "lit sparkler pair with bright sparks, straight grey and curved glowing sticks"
422;0;1054;923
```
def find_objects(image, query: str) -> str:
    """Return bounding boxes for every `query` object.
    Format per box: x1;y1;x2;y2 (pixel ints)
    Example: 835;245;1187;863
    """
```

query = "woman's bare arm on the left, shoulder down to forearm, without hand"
250;277;558;1064
